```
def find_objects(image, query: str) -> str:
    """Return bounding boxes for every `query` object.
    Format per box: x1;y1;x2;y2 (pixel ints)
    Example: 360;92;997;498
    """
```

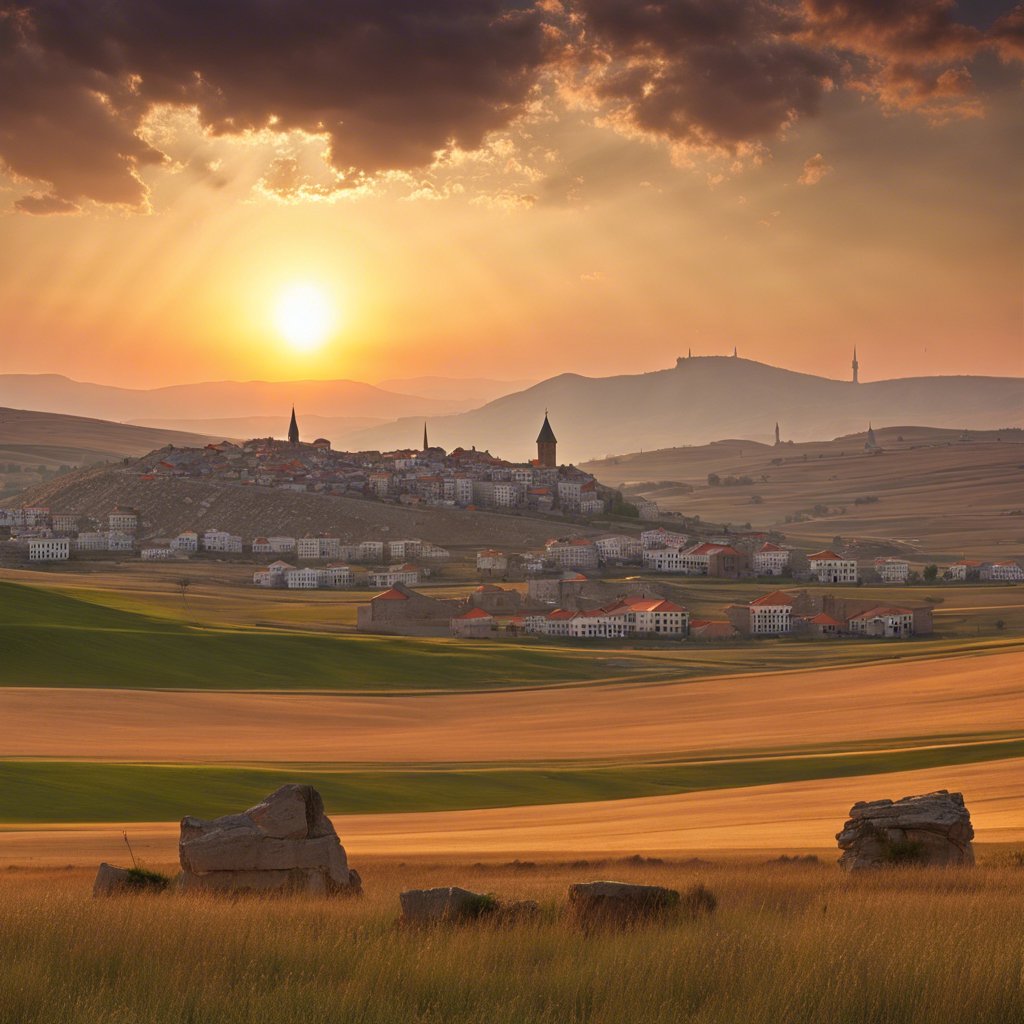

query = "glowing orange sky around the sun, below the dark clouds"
0;4;1024;386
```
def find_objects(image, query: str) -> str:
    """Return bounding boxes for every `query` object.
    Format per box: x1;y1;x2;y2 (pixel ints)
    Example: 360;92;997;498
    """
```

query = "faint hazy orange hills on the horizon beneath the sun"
0;374;467;423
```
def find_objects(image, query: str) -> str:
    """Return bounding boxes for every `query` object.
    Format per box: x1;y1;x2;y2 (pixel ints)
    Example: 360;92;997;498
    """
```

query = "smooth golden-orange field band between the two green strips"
0;651;1024;764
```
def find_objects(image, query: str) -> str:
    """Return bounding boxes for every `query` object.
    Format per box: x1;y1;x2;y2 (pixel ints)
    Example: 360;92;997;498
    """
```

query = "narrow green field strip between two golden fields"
0;736;1024;824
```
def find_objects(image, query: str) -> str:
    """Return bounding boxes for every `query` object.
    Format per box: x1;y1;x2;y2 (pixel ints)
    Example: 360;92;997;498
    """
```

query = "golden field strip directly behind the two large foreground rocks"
6;759;1024;867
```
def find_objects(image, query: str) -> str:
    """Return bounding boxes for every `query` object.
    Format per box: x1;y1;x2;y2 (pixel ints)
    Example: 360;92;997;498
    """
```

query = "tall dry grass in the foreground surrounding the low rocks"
0;862;1024;1024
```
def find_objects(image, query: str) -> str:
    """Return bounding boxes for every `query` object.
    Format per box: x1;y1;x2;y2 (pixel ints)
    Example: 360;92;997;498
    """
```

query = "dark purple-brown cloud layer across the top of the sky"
0;0;1024;213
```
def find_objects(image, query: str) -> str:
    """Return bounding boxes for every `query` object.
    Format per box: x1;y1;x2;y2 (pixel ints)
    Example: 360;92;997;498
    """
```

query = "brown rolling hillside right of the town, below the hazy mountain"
584;427;1024;558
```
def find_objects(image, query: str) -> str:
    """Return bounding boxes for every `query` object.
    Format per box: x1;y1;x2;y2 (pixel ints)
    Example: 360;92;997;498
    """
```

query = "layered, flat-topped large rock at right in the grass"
836;790;974;871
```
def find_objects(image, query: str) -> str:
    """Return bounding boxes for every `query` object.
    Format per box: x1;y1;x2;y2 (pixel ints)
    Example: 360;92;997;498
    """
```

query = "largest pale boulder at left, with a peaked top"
178;784;360;895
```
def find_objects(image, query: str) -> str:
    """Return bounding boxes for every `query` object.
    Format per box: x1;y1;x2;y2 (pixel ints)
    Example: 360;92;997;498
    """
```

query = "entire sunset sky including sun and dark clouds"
0;0;1024;386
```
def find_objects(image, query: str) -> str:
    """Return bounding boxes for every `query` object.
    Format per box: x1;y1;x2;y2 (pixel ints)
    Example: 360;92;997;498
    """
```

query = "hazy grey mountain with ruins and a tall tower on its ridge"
356;356;1024;462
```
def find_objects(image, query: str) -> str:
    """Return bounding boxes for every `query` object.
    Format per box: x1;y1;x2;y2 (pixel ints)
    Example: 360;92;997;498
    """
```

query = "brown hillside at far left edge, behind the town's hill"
0;409;222;496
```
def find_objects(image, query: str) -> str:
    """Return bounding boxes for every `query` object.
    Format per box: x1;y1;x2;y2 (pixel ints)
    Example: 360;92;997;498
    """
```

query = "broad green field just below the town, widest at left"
0;581;1024;692
